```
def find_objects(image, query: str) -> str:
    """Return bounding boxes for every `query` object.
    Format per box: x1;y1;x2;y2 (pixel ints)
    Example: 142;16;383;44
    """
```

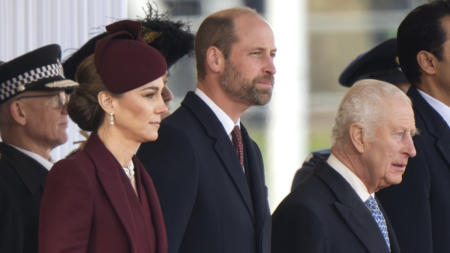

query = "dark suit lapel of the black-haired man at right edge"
407;86;450;168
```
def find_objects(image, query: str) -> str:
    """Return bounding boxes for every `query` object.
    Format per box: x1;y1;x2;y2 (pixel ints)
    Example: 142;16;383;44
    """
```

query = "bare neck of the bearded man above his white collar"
197;81;251;123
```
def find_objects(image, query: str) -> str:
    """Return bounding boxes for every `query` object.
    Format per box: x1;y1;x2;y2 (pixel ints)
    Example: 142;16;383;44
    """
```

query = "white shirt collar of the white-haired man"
327;154;374;202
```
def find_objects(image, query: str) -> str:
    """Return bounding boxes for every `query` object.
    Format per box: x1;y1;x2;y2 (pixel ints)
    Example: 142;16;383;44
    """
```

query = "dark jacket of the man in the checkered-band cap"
0;143;48;253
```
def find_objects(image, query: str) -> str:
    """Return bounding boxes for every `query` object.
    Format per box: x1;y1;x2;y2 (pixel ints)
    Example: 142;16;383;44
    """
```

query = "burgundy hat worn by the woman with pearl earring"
95;20;167;94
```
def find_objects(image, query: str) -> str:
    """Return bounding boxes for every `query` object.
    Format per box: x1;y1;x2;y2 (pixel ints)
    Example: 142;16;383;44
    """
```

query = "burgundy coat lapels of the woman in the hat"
83;132;167;253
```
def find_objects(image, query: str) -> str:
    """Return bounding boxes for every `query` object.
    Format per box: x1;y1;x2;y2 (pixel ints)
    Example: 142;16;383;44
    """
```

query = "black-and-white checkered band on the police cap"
0;63;64;100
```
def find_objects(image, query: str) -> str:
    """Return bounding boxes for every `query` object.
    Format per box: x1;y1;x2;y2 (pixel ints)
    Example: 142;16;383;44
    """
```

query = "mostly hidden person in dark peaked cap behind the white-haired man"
291;38;411;190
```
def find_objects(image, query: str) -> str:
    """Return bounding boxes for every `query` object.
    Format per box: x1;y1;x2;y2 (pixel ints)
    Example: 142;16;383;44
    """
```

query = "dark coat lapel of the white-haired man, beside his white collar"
314;160;389;253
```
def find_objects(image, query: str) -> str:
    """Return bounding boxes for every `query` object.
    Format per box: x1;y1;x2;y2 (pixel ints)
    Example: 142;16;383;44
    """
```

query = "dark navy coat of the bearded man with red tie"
137;92;270;253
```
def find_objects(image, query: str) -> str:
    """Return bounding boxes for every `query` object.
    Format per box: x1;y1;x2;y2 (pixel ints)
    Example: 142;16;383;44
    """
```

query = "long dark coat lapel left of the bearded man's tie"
181;92;254;219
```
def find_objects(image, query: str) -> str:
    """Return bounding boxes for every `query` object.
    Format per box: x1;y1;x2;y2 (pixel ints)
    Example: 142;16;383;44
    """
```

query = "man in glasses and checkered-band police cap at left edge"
0;45;78;253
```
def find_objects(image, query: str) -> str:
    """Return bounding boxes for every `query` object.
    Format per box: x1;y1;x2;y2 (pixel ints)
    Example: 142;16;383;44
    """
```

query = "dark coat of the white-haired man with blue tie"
272;160;400;253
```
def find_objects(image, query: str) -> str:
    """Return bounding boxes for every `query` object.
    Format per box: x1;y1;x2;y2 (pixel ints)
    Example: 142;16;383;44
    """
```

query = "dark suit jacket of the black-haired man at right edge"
377;87;450;253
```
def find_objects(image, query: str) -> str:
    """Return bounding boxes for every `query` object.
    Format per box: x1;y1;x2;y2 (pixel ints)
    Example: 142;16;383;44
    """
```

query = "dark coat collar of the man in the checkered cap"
0;142;48;194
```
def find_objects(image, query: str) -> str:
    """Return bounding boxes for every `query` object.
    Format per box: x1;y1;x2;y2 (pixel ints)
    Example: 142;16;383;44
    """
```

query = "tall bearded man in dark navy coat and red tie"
137;8;276;253
